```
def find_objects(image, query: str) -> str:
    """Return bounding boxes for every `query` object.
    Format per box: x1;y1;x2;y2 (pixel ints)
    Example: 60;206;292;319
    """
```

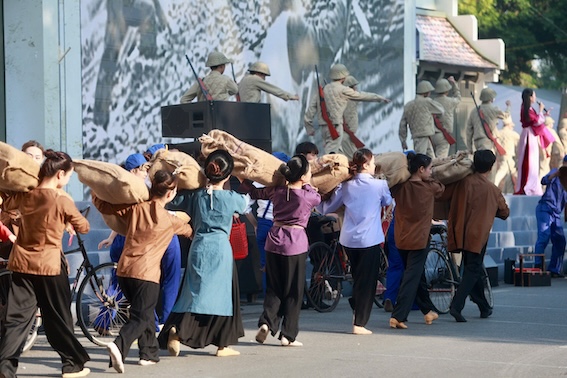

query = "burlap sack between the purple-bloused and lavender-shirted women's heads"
309;154;351;194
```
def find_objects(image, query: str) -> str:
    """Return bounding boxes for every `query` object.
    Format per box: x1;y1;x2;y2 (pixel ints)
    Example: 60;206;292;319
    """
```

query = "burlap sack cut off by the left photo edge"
0;142;39;192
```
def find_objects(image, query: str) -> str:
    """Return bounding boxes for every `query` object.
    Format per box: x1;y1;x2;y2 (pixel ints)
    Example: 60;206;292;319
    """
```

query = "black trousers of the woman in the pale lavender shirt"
344;245;382;327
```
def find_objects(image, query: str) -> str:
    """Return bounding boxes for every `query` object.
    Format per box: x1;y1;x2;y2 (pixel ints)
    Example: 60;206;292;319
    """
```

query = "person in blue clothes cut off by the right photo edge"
535;155;567;277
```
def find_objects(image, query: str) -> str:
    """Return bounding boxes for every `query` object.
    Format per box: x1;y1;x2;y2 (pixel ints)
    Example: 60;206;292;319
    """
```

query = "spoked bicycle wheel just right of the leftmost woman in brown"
76;263;130;346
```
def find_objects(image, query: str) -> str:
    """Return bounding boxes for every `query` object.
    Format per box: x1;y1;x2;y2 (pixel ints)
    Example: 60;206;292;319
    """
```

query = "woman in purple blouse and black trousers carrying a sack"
241;155;321;346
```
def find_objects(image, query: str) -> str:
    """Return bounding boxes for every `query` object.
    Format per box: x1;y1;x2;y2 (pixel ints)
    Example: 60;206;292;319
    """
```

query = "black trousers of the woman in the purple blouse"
258;251;307;342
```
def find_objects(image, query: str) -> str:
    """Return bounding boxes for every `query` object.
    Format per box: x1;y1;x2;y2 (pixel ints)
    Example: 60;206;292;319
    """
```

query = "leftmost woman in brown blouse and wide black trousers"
0;150;90;378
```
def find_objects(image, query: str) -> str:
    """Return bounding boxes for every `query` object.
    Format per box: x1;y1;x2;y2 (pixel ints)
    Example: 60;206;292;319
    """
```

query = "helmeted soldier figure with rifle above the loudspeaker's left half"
180;51;238;104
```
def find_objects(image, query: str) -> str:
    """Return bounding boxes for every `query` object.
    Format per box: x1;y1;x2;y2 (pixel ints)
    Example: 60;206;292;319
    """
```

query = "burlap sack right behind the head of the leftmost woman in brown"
73;160;150;205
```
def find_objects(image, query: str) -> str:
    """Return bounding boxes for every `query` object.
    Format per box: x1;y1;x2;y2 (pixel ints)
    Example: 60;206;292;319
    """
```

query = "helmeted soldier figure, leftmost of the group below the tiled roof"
399;81;445;158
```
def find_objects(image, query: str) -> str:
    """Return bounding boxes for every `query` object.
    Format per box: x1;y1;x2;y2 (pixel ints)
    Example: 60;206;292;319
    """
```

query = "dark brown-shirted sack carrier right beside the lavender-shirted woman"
390;152;445;328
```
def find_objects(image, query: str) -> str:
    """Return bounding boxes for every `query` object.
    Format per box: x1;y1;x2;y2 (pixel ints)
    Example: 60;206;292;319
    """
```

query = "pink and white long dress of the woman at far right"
514;108;555;196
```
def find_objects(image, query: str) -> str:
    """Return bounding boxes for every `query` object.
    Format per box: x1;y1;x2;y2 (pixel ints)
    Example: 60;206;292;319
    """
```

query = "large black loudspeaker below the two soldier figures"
161;101;272;144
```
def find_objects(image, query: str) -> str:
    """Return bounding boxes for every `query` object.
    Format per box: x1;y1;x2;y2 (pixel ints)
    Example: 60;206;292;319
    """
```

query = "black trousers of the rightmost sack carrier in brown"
451;244;490;312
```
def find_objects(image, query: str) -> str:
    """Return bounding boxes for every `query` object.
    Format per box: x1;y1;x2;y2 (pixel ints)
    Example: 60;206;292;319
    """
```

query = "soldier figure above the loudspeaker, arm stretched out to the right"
238;62;299;102
